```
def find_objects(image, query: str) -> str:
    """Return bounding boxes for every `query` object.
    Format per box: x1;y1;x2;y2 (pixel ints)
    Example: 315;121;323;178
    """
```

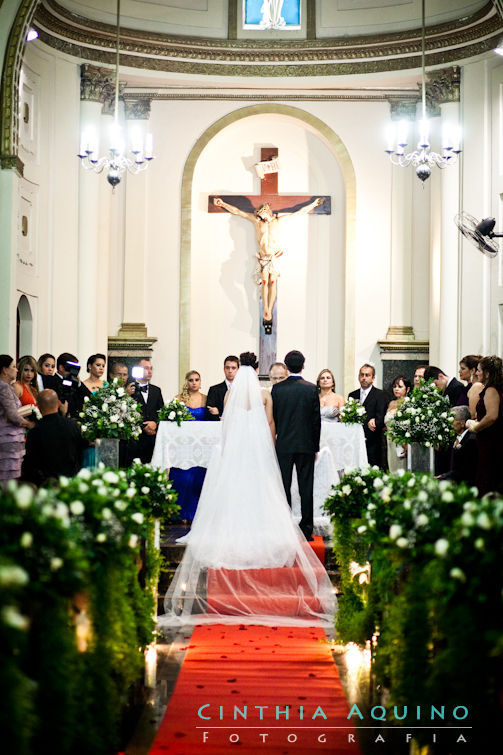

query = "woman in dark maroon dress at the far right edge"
466;356;503;496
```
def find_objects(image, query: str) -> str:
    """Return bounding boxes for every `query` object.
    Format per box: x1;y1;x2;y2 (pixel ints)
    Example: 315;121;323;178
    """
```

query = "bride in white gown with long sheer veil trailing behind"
159;352;335;628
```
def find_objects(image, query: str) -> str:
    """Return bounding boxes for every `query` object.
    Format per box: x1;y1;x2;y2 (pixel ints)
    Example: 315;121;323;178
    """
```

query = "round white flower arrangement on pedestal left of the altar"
79;378;143;440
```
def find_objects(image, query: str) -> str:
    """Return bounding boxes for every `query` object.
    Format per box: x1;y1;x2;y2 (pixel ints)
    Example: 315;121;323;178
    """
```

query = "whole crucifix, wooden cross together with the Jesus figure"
208;147;331;377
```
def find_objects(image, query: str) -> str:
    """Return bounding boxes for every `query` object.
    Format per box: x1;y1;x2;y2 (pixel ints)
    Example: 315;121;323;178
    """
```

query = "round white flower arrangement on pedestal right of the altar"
387;382;455;447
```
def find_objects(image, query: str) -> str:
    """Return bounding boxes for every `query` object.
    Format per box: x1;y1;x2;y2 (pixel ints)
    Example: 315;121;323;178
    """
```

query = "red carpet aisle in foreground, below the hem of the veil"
150;624;360;755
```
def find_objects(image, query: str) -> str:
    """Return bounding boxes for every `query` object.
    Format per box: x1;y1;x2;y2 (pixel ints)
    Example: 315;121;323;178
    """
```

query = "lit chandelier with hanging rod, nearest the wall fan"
386;0;461;181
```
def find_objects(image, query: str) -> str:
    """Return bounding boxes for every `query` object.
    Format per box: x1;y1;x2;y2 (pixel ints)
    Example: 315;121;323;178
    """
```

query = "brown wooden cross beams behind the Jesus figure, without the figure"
208;147;331;378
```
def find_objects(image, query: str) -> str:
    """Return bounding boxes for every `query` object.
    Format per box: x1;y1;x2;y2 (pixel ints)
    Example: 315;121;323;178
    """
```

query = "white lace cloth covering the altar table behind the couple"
152;420;368;535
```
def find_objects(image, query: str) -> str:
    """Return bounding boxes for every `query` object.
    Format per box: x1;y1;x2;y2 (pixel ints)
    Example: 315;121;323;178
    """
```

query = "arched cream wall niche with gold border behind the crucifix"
180;103;356;389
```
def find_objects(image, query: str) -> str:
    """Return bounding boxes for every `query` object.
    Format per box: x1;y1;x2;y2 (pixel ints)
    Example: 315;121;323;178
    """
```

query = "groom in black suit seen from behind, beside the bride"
271;351;321;540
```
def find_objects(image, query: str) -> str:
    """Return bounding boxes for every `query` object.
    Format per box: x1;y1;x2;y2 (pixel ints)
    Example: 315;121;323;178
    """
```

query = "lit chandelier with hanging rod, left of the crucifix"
78;0;154;191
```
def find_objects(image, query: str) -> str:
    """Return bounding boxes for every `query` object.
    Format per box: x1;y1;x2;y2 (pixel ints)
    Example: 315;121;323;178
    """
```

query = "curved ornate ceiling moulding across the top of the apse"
34;0;503;80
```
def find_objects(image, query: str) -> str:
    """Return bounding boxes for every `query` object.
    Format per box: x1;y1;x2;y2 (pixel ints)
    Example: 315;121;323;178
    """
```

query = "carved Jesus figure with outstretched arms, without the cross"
213;197;325;333
